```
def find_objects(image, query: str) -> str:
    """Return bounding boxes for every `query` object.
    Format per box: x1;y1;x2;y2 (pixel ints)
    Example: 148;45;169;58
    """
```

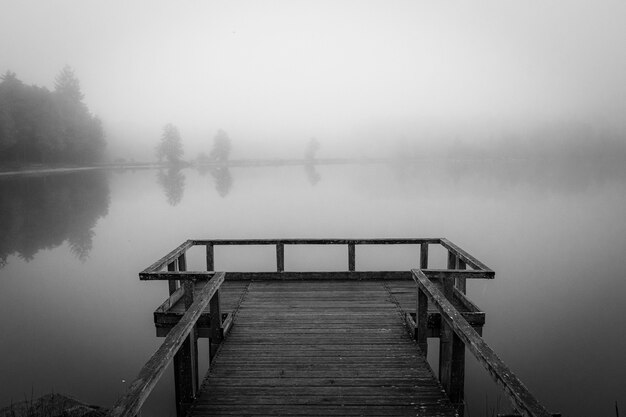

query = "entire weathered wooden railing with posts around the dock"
110;238;559;417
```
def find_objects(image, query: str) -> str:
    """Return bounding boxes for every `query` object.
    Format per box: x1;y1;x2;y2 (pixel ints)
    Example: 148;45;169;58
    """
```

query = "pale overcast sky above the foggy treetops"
0;0;626;156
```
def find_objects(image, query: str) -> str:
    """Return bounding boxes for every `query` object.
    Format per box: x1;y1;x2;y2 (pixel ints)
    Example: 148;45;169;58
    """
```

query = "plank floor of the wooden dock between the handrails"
188;280;456;416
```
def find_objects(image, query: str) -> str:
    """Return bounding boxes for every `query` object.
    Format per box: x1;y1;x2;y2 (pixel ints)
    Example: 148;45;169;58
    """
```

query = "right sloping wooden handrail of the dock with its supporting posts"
411;268;552;417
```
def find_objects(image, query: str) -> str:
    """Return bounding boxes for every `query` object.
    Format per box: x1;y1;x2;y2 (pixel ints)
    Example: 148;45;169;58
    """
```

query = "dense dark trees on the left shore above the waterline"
0;66;106;165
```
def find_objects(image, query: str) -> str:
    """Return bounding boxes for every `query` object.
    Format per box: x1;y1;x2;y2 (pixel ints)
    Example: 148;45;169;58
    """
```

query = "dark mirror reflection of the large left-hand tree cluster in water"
0;171;110;267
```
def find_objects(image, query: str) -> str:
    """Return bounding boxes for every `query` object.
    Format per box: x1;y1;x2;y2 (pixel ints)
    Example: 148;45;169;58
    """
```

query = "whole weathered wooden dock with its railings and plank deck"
111;238;551;417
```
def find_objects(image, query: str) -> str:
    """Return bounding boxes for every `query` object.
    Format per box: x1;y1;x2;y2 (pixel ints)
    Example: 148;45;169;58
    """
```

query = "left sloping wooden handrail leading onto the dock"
109;272;226;417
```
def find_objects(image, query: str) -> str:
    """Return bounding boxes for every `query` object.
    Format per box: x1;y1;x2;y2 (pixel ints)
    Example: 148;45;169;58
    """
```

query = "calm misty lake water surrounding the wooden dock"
0;161;626;416
